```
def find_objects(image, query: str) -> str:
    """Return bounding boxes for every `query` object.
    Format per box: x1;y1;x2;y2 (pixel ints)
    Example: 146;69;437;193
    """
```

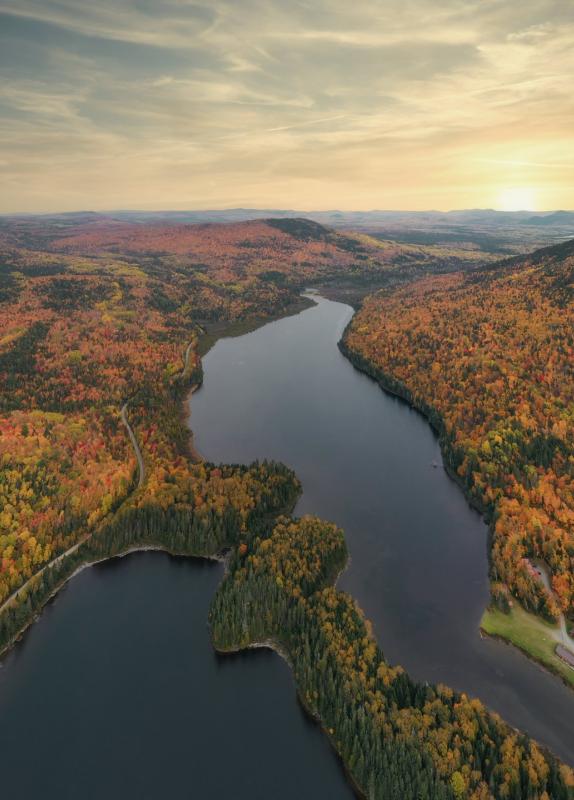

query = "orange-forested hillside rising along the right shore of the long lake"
345;241;574;664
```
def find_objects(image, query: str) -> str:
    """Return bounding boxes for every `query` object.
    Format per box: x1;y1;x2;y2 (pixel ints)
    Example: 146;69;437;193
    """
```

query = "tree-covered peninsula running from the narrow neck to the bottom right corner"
210;517;574;800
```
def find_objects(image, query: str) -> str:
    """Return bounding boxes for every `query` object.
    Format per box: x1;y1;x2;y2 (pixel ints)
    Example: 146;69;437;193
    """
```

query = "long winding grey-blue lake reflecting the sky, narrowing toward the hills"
190;298;574;764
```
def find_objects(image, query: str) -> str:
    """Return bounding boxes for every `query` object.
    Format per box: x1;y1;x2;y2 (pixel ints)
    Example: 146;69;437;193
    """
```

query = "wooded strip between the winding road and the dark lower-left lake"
0;462;300;652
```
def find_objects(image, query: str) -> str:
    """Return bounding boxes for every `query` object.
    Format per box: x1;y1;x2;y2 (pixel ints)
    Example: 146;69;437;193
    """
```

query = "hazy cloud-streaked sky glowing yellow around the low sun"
0;0;574;213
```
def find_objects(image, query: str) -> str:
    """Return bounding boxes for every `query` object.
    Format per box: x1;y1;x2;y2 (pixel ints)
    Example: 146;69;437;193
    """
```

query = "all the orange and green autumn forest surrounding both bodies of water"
0;209;574;800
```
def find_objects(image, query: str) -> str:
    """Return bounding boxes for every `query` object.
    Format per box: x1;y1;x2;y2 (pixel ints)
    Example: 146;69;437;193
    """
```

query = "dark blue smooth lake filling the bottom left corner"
0;553;353;800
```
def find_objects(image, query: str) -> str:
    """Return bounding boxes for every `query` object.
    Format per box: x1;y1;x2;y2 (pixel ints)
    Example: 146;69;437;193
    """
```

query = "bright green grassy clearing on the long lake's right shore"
480;602;574;688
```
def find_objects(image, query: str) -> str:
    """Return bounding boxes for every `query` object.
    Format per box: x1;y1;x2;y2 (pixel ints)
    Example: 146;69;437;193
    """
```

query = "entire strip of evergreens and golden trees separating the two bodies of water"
0;476;574;800
